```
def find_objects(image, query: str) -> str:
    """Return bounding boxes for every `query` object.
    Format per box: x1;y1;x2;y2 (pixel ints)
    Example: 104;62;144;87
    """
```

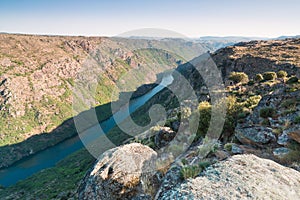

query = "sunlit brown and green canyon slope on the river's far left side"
0;34;213;167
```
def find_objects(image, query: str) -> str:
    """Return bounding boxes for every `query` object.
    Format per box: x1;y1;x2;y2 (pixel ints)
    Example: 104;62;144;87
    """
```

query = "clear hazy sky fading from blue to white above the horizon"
0;0;300;37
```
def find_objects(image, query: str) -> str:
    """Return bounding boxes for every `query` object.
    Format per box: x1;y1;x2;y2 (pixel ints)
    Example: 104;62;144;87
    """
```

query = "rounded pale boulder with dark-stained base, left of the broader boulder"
78;143;158;200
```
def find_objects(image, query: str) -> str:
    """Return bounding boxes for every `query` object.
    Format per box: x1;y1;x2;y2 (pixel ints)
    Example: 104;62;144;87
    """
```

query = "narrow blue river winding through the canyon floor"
0;75;173;187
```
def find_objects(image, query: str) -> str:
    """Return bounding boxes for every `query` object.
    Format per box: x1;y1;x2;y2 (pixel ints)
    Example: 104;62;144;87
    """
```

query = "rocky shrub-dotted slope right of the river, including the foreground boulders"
79;39;300;199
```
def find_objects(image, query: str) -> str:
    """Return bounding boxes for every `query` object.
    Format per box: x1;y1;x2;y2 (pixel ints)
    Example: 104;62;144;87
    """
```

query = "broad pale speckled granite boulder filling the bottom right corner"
157;155;300;200
